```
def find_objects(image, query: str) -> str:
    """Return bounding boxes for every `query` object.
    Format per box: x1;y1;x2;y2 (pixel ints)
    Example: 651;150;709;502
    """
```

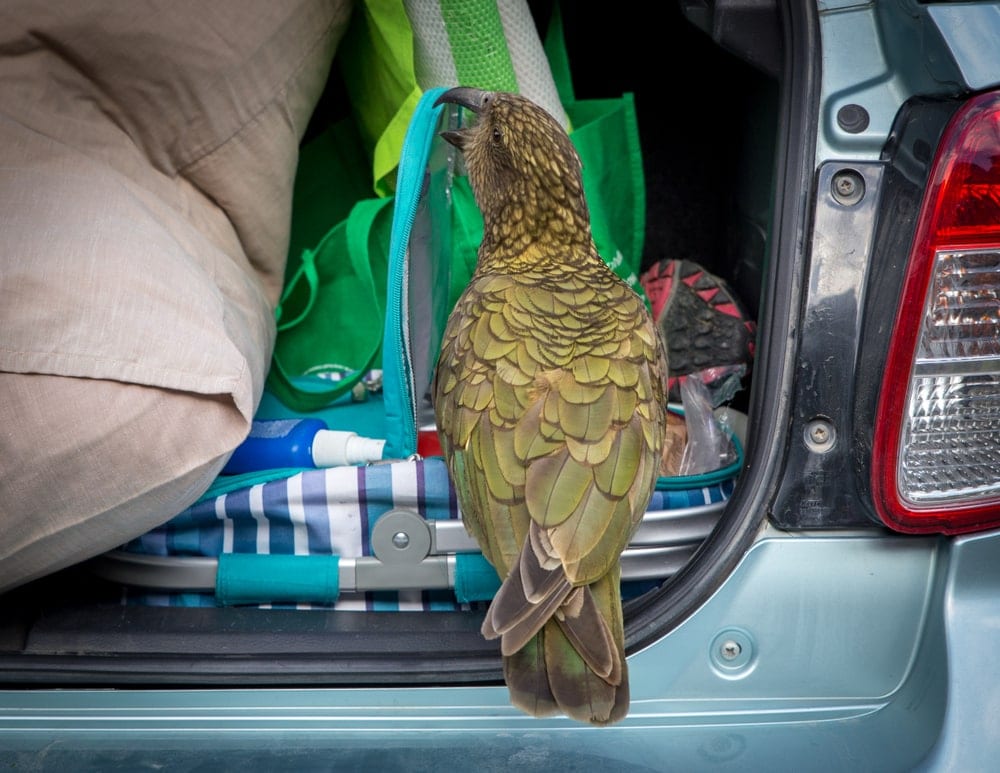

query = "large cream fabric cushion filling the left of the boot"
0;0;350;590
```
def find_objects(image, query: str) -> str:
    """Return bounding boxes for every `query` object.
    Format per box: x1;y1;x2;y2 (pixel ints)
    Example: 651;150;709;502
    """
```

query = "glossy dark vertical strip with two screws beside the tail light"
772;160;884;529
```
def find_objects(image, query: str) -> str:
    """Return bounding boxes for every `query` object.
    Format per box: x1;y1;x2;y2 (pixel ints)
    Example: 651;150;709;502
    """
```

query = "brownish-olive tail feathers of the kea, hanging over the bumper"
504;571;629;725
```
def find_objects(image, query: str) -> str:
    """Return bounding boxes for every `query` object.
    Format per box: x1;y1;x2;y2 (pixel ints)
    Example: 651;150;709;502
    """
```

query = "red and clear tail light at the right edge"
871;93;1000;534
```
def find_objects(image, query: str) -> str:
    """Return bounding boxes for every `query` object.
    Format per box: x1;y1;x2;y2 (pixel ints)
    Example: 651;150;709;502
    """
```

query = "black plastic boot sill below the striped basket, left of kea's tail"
0;602;501;688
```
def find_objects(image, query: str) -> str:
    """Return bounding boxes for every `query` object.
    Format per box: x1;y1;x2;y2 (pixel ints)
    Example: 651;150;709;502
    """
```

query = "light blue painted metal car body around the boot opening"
0;0;1000;772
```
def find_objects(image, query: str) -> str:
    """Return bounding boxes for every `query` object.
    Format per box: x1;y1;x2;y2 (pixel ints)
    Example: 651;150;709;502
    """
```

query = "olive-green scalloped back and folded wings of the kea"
435;276;664;651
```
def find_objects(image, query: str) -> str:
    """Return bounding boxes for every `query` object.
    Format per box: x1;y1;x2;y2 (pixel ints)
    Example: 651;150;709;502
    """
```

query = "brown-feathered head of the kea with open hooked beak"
434;86;590;252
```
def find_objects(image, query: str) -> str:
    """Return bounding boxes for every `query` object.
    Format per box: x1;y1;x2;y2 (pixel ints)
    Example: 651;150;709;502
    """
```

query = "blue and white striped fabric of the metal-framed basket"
124;457;733;611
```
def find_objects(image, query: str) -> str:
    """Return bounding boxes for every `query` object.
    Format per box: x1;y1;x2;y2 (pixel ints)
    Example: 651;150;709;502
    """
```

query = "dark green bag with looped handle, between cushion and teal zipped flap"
268;120;392;412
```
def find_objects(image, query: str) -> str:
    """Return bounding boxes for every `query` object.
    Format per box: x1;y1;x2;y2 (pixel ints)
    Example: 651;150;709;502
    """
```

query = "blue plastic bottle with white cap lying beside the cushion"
222;419;385;475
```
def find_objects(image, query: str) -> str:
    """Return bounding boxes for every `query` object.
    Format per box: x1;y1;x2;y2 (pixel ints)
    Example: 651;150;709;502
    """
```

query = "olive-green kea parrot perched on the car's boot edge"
431;86;667;725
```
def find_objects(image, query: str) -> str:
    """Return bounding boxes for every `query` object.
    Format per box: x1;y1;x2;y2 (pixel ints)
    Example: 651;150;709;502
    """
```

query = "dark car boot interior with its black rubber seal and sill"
0;2;796;687
